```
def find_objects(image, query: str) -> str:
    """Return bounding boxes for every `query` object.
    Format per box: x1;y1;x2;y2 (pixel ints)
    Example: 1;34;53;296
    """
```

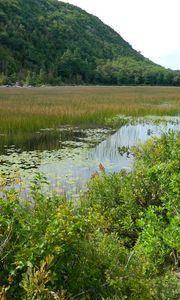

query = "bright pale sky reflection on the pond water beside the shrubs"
40;117;180;197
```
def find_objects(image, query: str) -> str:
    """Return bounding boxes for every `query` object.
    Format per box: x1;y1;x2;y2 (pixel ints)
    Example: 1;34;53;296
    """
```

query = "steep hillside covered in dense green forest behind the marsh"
0;0;180;85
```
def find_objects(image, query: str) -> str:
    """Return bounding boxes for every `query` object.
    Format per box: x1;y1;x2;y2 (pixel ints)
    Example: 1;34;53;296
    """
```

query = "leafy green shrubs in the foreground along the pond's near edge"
0;133;180;300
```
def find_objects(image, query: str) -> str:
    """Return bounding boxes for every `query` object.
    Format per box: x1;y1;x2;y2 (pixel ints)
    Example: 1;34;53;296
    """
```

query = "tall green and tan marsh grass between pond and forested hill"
0;86;180;134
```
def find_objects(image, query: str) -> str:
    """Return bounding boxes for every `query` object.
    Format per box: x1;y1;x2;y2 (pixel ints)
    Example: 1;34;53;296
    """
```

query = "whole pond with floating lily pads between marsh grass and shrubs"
0;117;180;197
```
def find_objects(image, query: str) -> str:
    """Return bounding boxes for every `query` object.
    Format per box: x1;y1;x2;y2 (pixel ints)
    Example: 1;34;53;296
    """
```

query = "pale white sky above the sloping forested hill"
61;0;180;70
